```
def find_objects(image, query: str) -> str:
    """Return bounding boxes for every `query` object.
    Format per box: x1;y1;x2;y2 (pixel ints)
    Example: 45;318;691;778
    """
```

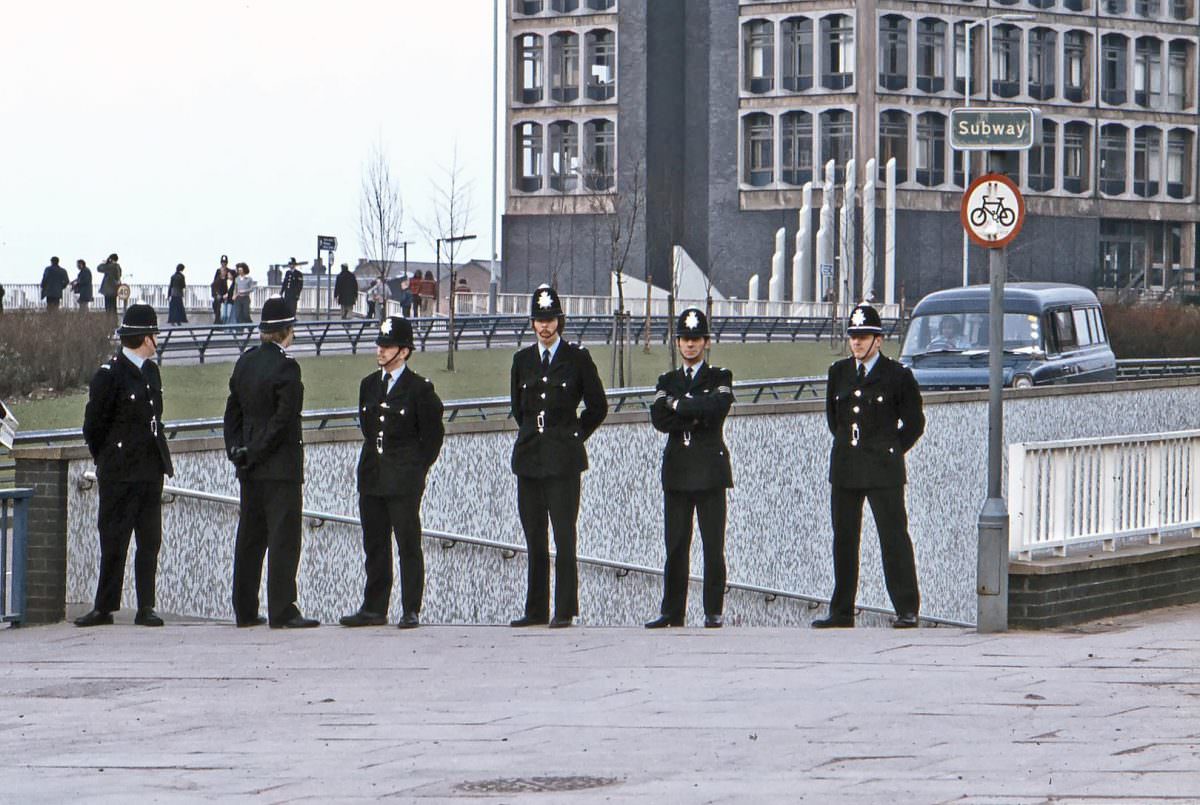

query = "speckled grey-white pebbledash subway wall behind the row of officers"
18;379;1200;625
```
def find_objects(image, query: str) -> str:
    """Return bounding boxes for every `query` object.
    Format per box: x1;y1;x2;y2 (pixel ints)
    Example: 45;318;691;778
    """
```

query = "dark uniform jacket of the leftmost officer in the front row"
83;353;175;481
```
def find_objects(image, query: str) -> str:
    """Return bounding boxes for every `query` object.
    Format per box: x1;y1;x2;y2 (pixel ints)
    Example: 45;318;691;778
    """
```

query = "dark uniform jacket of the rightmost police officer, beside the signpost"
826;355;925;489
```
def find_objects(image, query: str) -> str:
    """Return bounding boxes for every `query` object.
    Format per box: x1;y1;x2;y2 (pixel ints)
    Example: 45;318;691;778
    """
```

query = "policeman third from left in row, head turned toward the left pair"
341;316;445;629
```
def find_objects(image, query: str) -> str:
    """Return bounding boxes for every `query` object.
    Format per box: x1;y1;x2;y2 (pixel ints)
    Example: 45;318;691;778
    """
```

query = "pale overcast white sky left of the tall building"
0;0;504;283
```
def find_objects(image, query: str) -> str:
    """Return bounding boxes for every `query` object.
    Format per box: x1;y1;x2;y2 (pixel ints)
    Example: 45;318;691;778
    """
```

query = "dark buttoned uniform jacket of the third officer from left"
359;367;445;497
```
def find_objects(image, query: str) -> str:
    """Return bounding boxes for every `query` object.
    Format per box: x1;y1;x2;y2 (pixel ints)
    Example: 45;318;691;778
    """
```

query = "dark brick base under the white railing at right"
1008;539;1200;629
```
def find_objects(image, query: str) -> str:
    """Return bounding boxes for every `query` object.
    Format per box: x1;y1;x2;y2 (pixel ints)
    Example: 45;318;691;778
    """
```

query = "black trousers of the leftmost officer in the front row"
96;477;162;612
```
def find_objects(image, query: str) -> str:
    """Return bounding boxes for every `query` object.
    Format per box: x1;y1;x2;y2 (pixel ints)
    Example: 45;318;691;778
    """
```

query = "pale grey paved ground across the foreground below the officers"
0;607;1200;805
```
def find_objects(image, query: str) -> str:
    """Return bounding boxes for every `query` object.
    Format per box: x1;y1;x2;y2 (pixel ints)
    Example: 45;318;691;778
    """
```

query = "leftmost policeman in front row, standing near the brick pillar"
76;305;174;626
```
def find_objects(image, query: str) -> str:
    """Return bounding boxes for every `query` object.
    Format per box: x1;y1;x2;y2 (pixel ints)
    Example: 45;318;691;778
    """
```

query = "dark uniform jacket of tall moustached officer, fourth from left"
511;340;608;477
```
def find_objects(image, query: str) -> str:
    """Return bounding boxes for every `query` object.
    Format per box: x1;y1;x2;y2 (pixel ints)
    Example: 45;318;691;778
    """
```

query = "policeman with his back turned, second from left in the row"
224;298;320;629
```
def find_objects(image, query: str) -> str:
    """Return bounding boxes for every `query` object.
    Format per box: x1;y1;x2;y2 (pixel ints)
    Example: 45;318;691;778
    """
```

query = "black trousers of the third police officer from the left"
359;493;425;615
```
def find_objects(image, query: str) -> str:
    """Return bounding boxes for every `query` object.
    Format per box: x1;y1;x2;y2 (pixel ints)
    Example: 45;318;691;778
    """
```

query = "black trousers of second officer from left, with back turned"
233;481;301;624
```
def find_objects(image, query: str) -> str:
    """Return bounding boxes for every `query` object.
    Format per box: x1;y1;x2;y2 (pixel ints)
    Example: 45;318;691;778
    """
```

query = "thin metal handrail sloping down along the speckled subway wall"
79;470;974;629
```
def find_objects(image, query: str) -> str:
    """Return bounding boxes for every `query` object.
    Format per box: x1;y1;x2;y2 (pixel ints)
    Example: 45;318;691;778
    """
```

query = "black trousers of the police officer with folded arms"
659;489;725;618
